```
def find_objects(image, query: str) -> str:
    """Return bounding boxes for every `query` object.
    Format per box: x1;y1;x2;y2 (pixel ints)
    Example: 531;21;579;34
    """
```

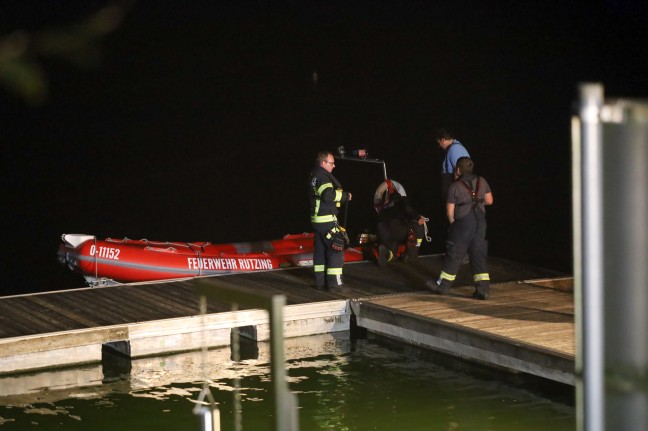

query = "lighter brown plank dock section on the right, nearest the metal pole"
352;279;575;385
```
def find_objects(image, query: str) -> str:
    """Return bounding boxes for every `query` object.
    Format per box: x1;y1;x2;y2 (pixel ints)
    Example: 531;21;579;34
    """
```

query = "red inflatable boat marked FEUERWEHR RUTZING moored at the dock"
57;233;363;285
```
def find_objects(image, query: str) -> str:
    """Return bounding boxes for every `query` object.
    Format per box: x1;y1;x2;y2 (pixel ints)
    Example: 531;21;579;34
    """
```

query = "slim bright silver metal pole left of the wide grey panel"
573;84;605;431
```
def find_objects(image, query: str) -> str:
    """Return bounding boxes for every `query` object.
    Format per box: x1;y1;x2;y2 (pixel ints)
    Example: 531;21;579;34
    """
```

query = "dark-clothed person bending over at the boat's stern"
376;179;425;266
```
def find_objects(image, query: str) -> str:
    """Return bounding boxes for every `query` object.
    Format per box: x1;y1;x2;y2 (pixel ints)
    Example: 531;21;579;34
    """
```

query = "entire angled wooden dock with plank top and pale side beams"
0;255;574;384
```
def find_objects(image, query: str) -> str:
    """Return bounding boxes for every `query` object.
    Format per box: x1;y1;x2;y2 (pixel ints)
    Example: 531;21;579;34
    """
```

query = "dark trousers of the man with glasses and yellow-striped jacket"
312;222;344;289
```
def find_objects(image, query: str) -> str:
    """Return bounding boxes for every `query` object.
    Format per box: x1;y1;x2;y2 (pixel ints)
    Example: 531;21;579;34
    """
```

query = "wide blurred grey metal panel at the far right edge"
601;96;648;431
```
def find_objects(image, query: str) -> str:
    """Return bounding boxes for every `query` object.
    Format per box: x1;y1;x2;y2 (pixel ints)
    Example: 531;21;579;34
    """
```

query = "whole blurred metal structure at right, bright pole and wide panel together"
572;84;648;431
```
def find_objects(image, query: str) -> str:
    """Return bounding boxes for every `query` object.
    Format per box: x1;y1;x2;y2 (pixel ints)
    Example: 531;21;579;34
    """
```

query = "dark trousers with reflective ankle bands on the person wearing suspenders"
437;208;490;295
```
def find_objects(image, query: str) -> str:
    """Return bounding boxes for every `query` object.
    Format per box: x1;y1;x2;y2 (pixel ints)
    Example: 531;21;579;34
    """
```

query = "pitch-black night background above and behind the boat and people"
0;0;648;295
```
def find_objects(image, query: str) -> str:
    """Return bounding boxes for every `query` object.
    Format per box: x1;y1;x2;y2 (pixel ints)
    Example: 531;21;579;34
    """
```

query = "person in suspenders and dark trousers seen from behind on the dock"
425;157;493;299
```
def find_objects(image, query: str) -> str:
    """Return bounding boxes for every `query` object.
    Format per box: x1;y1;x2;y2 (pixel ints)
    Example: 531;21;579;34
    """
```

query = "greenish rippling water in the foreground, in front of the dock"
0;333;576;431
